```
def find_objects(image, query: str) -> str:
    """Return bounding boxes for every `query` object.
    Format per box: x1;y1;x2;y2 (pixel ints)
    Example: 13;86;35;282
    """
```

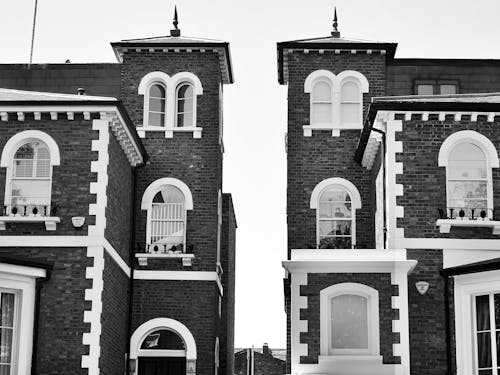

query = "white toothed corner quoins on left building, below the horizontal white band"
81;246;104;375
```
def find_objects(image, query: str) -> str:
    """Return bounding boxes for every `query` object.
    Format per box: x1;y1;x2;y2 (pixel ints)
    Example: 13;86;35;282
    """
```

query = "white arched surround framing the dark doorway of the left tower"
130;318;197;375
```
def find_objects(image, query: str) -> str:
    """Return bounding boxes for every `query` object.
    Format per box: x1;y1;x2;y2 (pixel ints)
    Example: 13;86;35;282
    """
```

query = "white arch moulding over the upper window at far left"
0;130;61;168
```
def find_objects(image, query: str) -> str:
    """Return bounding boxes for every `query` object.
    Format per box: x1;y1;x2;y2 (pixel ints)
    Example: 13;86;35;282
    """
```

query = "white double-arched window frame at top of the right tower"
303;69;370;137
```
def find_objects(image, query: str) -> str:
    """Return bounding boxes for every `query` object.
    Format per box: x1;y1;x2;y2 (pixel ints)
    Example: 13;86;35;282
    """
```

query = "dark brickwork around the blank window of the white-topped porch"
300;273;399;363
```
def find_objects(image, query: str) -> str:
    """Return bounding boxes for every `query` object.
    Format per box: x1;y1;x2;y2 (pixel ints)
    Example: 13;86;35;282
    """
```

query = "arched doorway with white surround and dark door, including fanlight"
130;318;196;375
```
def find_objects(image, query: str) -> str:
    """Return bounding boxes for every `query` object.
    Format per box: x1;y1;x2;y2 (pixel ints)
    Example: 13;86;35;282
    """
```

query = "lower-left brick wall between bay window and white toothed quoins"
0;247;93;375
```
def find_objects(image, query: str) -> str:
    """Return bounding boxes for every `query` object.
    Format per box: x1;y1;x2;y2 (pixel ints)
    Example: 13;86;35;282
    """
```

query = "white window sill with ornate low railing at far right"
436;207;500;235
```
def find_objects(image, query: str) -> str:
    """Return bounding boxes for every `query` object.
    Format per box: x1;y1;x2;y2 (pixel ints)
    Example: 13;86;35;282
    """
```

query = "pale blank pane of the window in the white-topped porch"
331;294;368;349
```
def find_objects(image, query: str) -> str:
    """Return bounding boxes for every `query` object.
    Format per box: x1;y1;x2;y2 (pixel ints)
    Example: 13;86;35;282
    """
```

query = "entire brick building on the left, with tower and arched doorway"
0;13;236;375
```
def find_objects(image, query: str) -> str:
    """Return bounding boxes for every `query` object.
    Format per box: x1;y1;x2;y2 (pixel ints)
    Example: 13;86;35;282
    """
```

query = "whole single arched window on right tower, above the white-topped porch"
311;178;361;249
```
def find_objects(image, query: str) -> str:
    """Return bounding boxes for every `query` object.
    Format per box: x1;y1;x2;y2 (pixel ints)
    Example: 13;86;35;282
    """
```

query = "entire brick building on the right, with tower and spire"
277;11;500;375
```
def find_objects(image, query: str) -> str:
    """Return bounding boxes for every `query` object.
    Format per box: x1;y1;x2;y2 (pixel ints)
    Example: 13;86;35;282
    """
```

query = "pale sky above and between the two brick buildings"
0;0;500;347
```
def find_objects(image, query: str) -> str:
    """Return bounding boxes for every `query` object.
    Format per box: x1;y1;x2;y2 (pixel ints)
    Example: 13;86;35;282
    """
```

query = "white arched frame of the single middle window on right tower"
310;177;361;248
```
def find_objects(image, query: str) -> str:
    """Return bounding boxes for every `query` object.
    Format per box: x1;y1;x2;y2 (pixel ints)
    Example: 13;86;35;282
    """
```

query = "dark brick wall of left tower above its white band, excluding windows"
121;51;222;271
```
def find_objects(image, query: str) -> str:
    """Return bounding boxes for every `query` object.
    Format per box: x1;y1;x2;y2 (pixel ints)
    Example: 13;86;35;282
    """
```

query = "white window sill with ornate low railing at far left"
0;204;61;231
